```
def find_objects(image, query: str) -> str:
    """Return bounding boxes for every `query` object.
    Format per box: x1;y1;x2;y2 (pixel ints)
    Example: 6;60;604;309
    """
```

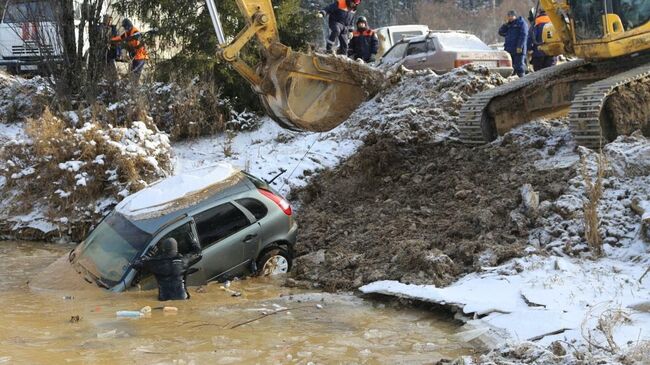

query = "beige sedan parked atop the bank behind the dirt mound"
380;31;512;77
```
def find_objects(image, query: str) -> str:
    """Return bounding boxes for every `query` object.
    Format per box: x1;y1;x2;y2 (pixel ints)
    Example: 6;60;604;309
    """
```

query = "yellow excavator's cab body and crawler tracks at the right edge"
459;0;650;148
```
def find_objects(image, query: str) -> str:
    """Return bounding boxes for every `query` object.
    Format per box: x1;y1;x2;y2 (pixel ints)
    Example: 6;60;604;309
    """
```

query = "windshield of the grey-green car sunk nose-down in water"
77;213;151;287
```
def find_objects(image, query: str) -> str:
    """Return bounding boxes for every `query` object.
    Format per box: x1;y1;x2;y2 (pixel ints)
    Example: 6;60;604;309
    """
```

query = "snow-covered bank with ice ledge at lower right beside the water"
360;132;650;364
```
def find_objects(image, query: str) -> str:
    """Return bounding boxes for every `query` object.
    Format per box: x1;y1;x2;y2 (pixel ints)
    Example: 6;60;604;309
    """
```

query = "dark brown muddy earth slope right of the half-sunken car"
295;124;574;290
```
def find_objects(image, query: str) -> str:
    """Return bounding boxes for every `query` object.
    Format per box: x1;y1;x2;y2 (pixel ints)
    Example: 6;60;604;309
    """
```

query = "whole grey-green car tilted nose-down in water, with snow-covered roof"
68;164;297;291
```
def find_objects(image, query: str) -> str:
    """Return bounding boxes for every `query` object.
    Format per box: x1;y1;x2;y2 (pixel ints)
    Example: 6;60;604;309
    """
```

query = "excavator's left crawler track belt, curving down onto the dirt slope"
458;60;588;144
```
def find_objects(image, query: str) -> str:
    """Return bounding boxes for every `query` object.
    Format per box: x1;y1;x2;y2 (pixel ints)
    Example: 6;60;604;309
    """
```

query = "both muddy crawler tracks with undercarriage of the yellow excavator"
458;53;650;148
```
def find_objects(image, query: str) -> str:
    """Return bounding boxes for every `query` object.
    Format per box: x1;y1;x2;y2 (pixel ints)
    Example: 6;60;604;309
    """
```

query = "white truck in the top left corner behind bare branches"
0;0;87;74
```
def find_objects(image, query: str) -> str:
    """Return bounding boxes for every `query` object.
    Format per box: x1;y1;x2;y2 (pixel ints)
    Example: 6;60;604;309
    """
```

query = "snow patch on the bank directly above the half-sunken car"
173;118;362;195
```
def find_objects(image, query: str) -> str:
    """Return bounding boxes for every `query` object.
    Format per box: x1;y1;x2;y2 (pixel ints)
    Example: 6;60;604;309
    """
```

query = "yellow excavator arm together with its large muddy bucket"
206;0;384;132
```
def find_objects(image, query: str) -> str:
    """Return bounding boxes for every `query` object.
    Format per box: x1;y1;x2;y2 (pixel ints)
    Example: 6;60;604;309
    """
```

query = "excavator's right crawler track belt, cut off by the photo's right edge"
569;64;650;148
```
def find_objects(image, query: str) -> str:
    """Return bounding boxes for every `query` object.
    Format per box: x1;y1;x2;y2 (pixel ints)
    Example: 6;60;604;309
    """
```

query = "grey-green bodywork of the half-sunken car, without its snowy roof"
69;166;297;291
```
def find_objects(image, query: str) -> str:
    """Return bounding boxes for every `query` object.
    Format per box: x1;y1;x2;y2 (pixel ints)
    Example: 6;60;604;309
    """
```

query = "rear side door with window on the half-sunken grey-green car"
194;203;259;281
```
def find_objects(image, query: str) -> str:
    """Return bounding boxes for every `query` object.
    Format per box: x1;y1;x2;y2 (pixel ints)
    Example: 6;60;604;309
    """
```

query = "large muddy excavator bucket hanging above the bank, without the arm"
259;47;383;132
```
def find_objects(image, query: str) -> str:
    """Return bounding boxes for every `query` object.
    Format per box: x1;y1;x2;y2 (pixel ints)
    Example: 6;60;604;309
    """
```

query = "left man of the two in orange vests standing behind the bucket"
318;0;361;55
